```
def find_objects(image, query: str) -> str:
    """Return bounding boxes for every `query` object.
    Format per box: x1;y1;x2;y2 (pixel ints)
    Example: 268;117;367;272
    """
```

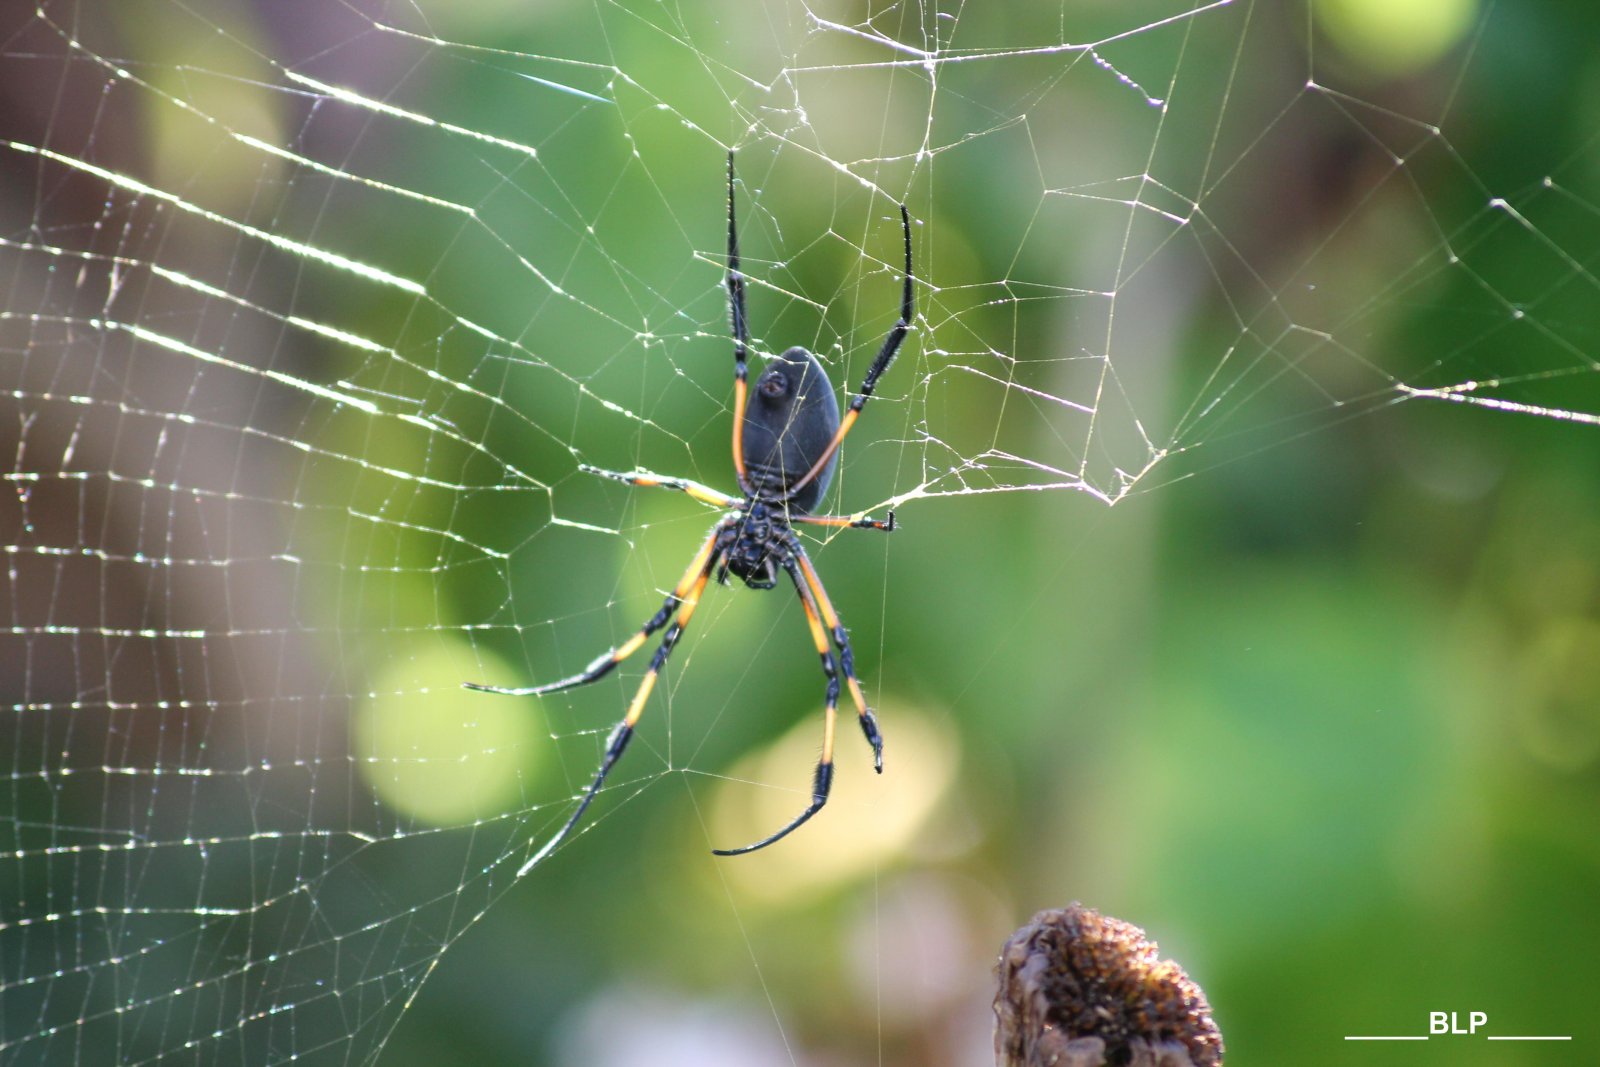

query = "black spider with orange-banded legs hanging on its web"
464;152;915;872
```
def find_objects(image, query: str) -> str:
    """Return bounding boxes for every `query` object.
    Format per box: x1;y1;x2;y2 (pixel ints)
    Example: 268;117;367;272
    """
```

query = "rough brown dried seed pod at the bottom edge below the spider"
995;904;1222;1067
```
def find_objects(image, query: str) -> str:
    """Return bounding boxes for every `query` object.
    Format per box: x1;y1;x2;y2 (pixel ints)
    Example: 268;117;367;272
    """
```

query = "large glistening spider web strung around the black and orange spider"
0;0;1600;1064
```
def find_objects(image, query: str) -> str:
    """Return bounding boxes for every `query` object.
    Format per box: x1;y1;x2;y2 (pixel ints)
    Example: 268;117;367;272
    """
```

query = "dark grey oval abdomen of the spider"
742;346;838;515
